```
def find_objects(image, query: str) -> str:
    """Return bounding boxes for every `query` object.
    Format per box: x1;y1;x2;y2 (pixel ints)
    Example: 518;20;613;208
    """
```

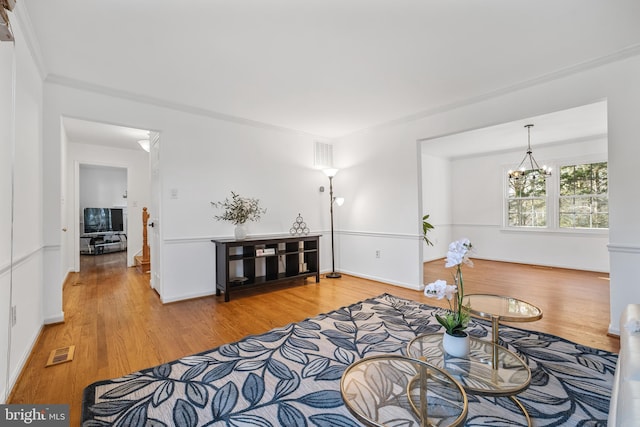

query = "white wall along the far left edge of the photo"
0;6;44;402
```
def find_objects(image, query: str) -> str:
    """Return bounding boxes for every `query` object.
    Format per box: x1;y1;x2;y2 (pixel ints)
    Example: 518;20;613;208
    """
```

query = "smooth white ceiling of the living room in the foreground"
18;0;640;147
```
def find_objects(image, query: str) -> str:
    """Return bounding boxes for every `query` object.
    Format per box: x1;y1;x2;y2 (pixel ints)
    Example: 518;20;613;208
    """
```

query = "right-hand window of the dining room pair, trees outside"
558;162;609;228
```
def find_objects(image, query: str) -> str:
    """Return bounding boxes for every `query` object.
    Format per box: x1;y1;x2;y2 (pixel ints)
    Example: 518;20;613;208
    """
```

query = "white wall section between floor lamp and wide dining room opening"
334;128;424;289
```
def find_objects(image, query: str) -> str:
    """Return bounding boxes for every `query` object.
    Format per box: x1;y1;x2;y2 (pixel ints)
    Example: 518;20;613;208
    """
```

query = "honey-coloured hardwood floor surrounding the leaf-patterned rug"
9;253;619;426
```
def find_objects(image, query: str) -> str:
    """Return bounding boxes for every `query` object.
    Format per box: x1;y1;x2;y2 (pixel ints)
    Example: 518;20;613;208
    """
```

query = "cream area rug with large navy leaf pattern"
82;294;618;427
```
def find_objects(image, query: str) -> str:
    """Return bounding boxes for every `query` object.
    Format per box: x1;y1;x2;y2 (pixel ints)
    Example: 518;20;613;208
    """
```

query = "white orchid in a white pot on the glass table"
424;239;473;357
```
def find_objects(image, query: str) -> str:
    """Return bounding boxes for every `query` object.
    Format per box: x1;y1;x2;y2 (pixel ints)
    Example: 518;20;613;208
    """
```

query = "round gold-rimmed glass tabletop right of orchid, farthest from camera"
462;294;542;322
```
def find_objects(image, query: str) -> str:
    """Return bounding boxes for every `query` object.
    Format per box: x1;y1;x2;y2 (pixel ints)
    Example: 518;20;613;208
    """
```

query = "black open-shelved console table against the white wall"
212;234;320;301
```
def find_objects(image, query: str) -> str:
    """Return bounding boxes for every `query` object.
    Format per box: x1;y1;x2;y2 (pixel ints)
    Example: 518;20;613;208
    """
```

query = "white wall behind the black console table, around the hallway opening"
44;83;329;311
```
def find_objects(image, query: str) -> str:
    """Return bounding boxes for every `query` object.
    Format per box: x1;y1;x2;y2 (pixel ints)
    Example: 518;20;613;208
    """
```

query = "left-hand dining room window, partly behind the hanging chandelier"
507;170;547;227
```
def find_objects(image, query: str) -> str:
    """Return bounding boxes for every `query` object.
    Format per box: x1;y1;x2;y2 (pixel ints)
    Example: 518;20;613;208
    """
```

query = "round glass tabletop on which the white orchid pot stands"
407;334;531;396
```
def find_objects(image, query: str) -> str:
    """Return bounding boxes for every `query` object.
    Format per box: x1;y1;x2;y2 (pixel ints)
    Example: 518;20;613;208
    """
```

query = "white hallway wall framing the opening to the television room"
66;143;150;271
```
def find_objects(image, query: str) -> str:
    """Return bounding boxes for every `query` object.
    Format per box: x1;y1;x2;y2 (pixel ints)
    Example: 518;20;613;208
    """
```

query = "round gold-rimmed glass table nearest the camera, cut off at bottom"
340;354;468;427
